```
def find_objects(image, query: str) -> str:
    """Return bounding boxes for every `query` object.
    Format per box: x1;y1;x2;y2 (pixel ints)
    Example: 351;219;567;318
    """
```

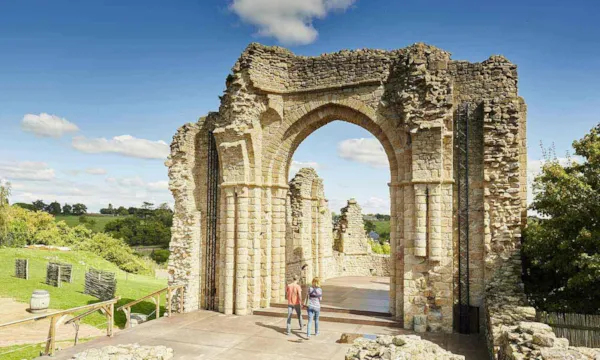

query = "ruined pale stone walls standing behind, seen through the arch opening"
285;172;390;283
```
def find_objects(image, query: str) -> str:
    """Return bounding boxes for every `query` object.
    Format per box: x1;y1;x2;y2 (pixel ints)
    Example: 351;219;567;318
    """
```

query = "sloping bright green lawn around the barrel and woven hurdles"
0;248;167;329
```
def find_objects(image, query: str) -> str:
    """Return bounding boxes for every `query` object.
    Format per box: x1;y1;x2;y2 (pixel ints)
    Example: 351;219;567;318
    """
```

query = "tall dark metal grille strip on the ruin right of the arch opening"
455;103;470;334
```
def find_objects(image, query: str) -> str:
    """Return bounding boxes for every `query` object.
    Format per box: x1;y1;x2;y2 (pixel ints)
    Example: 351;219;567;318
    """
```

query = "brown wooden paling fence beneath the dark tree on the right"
536;312;600;348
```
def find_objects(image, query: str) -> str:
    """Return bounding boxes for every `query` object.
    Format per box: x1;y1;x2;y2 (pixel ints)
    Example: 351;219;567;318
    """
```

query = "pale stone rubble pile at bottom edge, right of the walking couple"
346;335;465;360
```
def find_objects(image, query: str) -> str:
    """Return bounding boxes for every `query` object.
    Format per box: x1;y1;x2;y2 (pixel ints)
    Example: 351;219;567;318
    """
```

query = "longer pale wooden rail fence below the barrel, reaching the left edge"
0;297;119;356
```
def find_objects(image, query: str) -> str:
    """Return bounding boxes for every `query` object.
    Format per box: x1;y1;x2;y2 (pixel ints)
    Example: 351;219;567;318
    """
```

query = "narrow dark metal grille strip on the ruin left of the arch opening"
204;131;219;310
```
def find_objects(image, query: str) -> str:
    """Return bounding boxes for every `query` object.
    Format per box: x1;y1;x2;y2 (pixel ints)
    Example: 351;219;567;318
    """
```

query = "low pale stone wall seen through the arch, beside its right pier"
334;251;391;276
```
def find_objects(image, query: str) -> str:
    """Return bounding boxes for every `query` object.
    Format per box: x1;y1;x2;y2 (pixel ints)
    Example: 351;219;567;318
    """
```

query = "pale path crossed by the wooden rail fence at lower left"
0;298;106;347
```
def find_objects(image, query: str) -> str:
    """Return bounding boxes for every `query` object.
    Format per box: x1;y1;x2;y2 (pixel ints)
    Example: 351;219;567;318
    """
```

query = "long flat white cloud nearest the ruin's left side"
72;135;169;159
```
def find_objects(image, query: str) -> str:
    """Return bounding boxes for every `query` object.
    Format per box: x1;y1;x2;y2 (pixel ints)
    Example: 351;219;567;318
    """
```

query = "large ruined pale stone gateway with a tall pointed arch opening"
167;44;526;332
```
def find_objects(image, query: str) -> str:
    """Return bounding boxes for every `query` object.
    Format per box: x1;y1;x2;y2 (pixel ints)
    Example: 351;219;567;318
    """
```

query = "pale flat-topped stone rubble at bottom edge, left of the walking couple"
72;344;173;360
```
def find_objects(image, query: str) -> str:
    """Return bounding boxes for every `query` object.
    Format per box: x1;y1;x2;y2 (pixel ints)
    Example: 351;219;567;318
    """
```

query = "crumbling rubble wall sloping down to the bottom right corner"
484;253;600;360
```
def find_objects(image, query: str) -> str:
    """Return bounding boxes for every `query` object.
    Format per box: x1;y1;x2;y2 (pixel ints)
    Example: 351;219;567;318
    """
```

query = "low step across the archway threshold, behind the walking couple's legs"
253;306;402;328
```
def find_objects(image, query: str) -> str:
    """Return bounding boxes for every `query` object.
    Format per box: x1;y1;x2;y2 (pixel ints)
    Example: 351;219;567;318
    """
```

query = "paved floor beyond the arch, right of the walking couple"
322;276;390;313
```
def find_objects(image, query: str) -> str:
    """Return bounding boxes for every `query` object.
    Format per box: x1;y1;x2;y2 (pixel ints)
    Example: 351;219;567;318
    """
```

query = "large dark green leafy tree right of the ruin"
523;124;600;313
